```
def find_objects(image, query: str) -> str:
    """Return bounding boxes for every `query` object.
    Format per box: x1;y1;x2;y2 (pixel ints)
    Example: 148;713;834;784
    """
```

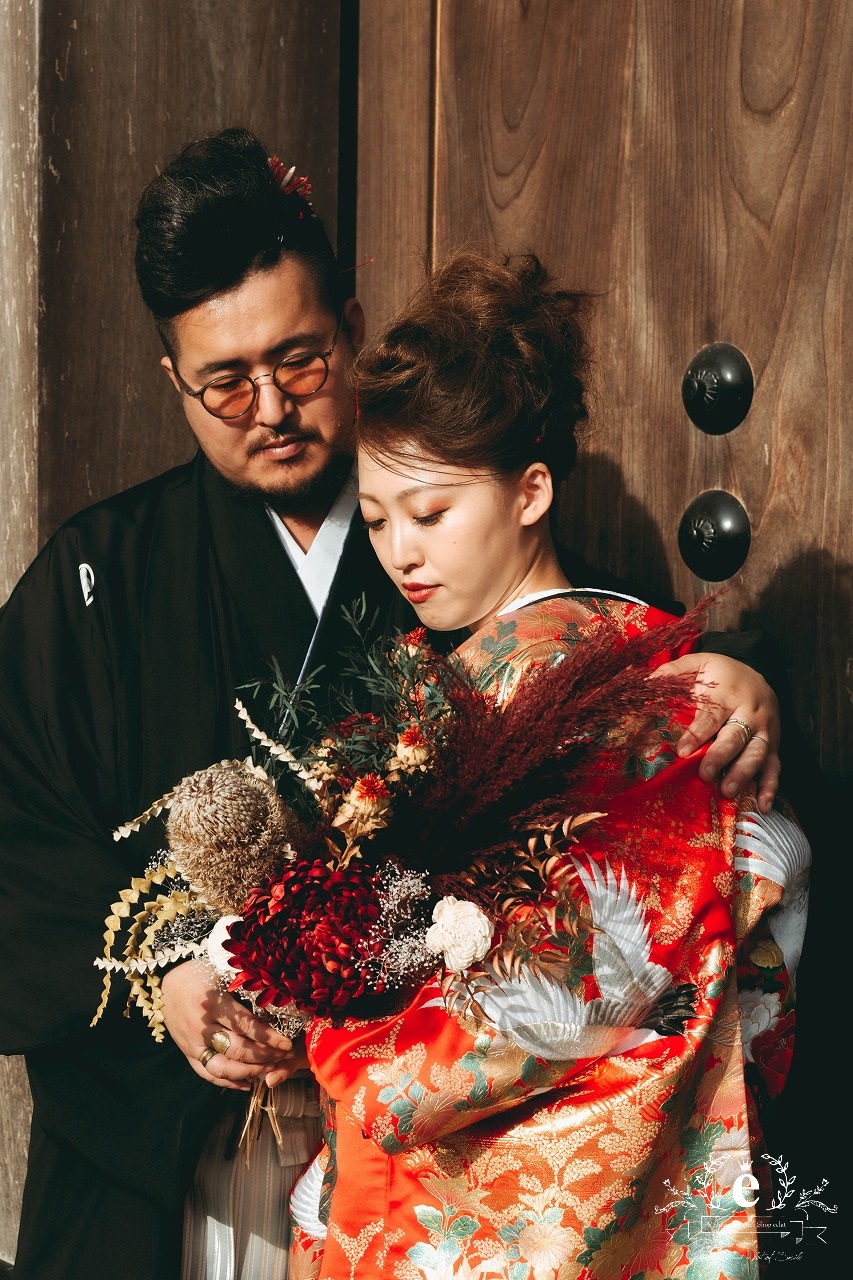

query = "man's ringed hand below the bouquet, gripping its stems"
161;960;307;1089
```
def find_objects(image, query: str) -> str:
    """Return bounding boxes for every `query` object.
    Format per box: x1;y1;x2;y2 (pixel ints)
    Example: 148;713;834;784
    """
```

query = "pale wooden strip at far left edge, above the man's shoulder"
0;0;38;602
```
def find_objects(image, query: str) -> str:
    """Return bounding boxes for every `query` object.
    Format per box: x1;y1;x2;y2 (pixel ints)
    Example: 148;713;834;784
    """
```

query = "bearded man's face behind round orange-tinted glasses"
161;257;364;515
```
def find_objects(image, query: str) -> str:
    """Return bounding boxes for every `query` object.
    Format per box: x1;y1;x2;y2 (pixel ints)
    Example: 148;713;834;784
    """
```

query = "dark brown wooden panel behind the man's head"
40;0;339;540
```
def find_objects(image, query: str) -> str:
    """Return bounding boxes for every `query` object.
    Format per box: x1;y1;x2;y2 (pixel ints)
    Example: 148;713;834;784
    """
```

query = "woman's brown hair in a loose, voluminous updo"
355;250;592;484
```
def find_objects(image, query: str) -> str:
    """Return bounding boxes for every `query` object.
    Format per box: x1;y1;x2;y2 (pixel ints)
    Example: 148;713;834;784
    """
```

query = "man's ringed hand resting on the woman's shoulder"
656;653;781;813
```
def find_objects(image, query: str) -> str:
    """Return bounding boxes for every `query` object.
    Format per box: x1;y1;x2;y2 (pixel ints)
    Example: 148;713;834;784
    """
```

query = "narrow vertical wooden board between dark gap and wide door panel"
357;0;434;330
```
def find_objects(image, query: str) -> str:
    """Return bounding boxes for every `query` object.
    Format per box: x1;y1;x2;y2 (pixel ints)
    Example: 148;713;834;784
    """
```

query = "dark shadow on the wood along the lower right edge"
740;549;853;1280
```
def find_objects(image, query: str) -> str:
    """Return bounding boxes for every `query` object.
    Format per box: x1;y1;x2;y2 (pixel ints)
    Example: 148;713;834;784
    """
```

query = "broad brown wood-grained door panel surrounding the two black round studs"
427;0;853;773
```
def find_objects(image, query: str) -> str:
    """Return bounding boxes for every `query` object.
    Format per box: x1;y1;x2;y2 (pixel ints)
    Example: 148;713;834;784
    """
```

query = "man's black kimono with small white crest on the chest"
0;456;394;1280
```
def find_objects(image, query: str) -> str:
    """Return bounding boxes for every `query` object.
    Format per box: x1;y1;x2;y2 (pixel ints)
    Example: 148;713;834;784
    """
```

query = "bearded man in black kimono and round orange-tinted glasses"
0;122;776;1280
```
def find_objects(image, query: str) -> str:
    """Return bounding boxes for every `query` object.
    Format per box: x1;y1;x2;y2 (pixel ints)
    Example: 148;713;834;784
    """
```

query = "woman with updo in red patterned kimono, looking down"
286;253;808;1280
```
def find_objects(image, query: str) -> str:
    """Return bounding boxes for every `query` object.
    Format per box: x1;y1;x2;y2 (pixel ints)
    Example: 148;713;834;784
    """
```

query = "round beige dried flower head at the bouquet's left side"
167;760;301;914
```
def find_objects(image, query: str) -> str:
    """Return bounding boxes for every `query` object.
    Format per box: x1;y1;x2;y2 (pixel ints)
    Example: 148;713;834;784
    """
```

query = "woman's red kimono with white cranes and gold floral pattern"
291;595;809;1280
